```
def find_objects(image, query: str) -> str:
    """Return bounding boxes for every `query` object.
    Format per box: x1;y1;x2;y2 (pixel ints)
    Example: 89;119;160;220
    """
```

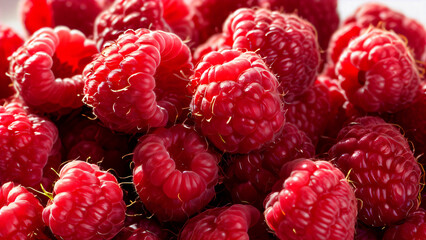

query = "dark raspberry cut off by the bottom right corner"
383;208;426;240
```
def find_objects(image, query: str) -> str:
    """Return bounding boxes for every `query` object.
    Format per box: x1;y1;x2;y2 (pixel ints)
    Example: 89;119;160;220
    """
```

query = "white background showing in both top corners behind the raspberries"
0;0;426;35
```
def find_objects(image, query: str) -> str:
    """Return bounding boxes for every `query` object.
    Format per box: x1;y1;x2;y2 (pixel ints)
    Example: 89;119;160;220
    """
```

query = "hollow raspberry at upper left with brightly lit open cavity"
9;27;97;113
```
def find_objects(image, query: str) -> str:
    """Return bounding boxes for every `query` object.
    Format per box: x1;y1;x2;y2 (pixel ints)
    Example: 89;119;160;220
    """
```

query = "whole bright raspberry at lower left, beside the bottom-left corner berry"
43;160;126;240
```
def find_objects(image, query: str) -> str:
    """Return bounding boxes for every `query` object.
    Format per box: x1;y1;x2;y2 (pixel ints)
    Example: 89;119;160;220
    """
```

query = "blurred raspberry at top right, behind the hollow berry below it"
343;3;426;60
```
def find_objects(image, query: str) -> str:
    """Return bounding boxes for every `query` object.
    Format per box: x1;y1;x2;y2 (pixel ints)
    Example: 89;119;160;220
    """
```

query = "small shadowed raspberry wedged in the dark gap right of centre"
285;81;331;145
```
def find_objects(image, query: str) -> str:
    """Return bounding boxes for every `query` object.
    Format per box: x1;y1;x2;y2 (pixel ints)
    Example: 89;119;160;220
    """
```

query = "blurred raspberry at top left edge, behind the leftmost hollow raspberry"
20;0;102;36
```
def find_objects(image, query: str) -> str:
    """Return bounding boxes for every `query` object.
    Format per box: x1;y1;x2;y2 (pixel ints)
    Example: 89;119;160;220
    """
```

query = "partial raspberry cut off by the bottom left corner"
0;182;44;240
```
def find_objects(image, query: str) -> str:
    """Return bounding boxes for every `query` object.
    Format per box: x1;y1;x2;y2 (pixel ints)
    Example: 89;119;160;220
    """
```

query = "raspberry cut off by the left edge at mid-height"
0;101;60;187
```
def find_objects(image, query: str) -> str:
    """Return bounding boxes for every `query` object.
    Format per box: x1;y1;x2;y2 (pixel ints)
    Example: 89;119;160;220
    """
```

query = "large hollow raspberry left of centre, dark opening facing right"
83;29;193;133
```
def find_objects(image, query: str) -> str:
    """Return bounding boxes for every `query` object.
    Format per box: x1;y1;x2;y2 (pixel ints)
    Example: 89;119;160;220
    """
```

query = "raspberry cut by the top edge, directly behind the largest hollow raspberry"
94;0;171;50
